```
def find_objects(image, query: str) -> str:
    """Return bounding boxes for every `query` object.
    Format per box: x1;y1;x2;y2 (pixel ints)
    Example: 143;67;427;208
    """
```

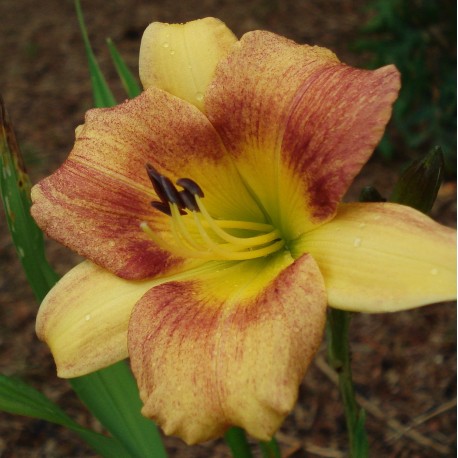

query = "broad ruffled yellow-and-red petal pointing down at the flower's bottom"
128;253;326;444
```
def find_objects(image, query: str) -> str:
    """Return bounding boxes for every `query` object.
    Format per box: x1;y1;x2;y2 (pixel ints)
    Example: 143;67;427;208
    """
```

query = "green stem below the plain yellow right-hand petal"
328;309;368;458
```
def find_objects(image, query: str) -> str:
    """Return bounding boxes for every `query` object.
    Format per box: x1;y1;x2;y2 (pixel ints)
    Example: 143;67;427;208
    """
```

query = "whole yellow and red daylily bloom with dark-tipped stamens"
32;19;456;443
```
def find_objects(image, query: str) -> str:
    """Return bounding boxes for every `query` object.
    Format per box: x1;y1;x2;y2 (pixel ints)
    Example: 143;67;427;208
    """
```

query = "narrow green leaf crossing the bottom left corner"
0;375;131;458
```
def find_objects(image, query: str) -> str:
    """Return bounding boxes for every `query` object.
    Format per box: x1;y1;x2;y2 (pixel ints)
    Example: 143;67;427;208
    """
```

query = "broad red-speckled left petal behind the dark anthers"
32;88;263;279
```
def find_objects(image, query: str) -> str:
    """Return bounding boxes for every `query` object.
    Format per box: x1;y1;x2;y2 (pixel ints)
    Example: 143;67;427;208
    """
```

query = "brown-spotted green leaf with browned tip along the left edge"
0;97;58;301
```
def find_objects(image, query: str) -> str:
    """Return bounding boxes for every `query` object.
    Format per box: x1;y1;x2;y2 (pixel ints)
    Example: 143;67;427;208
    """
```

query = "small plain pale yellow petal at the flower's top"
140;18;237;110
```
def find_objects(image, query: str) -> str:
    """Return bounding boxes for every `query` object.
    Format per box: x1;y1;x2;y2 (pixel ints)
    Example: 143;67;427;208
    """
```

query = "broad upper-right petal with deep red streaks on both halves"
205;31;399;239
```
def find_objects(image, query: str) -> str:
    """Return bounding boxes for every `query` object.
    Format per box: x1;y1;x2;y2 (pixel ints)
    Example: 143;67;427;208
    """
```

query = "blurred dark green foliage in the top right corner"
352;0;457;178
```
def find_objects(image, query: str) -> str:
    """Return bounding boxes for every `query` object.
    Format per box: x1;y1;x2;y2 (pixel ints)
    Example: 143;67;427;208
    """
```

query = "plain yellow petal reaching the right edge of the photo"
293;203;456;312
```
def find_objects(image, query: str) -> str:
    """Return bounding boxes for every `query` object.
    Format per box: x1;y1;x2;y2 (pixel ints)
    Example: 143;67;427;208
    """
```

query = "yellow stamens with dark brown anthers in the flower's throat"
140;164;285;261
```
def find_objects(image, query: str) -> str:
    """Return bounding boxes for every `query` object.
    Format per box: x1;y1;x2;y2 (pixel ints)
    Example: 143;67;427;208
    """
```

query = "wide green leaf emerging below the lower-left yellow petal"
70;361;167;458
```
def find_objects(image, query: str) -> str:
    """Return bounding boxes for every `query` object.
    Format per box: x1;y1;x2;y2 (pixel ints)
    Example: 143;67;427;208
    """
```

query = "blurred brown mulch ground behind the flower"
0;0;456;458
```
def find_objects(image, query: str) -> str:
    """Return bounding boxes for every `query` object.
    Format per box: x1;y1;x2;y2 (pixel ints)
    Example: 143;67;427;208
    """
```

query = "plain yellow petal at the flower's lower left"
36;261;161;378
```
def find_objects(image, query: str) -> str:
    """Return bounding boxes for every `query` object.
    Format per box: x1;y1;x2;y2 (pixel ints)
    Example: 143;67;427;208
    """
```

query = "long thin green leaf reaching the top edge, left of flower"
75;0;116;108
